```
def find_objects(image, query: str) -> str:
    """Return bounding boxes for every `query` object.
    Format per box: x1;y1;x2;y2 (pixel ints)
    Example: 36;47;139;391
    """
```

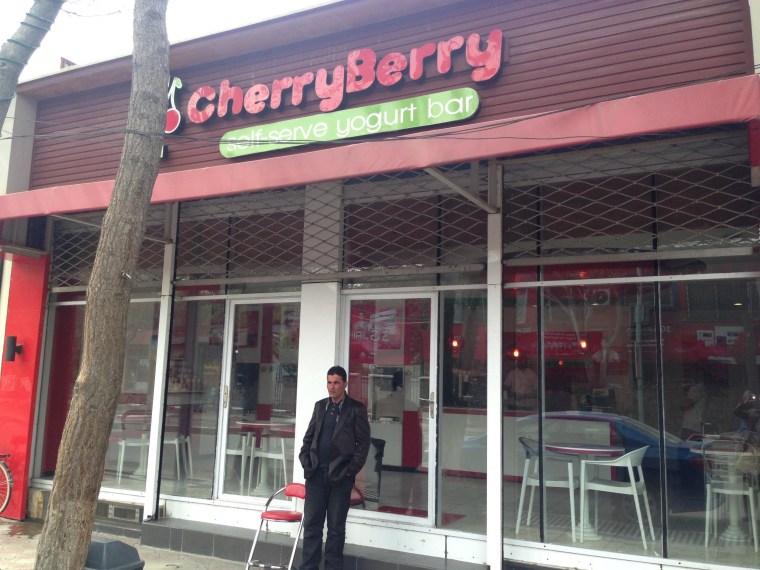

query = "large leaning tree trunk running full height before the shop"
35;0;169;570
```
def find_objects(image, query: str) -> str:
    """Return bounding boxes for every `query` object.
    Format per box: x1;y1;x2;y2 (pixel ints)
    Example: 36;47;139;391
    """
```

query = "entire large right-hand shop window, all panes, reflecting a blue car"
503;270;760;567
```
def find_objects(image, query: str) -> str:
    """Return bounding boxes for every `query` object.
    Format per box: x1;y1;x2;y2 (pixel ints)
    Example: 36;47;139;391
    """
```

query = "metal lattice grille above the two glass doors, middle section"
177;165;487;282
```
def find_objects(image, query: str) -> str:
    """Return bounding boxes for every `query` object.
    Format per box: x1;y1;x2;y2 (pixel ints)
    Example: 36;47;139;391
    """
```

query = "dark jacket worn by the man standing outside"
298;396;370;483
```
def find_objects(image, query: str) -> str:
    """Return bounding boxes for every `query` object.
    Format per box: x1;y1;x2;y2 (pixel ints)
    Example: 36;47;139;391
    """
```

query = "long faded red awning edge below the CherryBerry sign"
0;75;760;220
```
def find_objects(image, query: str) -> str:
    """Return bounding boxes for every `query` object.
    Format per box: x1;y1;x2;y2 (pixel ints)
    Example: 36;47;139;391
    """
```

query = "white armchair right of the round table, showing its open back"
581;445;654;550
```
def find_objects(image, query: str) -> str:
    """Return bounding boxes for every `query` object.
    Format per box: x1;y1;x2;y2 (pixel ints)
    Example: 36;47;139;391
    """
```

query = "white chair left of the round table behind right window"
515;437;578;542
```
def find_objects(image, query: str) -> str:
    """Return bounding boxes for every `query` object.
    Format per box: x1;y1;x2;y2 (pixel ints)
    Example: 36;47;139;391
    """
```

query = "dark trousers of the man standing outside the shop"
301;468;354;570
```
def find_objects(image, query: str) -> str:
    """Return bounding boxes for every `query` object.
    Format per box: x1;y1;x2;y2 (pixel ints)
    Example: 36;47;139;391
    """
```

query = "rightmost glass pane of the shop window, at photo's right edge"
661;280;760;568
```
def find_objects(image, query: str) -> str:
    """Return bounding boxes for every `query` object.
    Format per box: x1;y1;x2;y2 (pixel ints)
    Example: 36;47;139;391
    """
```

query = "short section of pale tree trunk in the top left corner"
0;0;66;127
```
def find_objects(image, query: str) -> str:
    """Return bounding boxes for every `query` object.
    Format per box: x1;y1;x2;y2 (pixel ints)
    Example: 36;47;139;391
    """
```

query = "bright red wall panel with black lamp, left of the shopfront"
0;255;49;520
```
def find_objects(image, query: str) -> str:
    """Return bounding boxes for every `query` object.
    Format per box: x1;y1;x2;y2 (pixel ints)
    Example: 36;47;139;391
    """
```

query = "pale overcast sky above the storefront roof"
0;0;340;81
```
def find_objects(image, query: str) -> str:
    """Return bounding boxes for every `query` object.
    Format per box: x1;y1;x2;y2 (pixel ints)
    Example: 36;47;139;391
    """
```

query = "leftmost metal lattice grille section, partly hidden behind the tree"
50;206;164;288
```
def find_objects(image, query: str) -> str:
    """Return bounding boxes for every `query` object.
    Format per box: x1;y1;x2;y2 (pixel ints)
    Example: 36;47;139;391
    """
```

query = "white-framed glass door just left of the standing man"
218;301;300;497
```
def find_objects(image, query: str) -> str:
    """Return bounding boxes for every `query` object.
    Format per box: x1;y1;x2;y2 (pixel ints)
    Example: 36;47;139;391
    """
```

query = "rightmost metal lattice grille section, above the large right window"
502;130;760;259
